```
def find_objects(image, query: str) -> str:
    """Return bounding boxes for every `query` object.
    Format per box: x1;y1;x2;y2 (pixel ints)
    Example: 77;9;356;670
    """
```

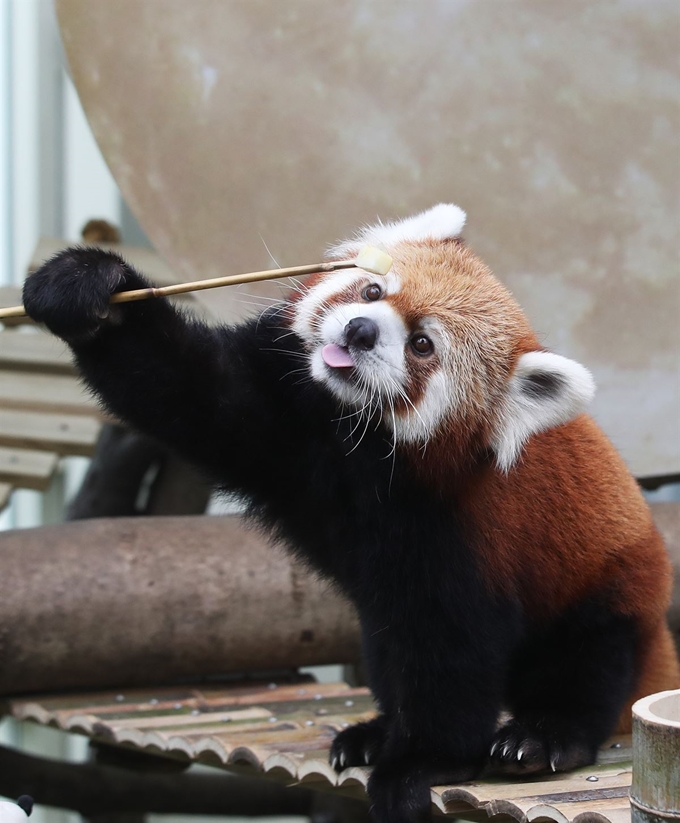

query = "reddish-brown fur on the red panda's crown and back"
391;244;680;730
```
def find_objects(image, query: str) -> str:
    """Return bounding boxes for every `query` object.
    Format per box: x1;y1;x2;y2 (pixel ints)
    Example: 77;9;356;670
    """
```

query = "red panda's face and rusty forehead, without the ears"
294;241;530;443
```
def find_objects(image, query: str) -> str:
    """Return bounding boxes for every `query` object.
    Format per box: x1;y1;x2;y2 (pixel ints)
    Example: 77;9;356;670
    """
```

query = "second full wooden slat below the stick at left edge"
0;369;100;416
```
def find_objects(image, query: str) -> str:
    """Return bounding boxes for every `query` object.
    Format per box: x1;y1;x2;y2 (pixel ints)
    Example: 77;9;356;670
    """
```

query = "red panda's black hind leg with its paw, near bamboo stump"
490;600;636;774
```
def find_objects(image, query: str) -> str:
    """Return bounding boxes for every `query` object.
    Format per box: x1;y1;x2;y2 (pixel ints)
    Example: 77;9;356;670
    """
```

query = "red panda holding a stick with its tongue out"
24;204;680;823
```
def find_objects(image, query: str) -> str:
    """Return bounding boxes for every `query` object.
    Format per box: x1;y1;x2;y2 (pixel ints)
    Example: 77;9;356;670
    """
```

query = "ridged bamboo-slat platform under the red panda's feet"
4;681;631;823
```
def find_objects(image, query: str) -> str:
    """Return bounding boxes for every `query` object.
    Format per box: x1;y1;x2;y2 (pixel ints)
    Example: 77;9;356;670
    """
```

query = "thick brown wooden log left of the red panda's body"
0;517;359;694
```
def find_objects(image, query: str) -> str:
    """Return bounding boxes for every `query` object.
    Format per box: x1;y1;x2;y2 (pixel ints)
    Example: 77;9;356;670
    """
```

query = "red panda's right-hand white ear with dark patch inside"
491;351;595;472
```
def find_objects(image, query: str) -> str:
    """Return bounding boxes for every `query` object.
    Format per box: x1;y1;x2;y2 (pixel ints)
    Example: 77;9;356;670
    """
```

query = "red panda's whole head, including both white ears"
292;204;594;470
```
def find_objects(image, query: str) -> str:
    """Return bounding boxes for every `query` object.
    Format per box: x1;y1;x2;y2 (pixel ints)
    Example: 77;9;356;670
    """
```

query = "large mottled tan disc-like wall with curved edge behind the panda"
57;0;680;476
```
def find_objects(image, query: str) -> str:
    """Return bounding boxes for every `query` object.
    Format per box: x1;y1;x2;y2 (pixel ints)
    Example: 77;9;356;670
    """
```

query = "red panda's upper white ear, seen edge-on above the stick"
328;203;465;258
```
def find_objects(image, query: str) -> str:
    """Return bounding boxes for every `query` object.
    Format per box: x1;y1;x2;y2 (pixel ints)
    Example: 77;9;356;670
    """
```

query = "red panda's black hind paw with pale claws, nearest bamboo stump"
489;720;595;775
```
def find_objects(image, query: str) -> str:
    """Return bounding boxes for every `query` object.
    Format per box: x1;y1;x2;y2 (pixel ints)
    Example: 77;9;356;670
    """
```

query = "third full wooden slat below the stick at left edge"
0;408;102;456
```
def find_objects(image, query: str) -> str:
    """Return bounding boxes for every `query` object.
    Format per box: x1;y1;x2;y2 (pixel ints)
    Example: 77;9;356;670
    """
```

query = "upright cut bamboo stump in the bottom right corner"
630;689;680;823
